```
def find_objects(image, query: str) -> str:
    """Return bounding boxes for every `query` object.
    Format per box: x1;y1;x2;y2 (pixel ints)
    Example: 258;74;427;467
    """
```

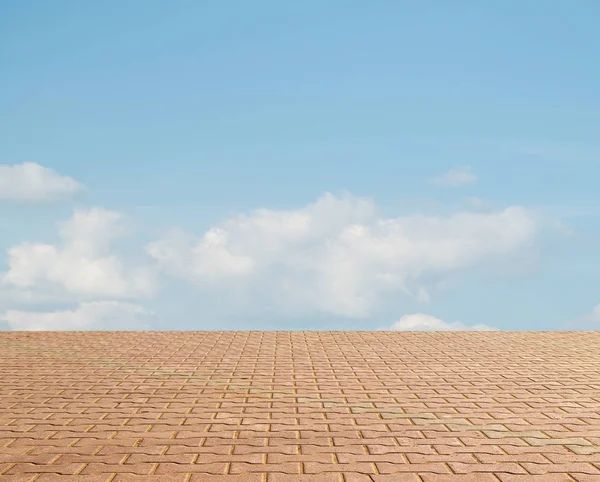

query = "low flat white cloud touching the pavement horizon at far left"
0;301;154;331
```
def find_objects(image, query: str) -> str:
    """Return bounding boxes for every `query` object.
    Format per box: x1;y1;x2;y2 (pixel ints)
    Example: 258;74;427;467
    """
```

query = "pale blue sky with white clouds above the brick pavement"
0;0;600;330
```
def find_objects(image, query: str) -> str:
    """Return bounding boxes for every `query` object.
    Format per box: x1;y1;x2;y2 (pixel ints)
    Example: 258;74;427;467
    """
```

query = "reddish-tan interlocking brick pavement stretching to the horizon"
0;332;600;482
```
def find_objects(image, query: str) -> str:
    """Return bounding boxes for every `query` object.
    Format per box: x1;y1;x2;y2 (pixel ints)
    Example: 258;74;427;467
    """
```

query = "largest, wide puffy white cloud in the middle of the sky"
147;194;538;317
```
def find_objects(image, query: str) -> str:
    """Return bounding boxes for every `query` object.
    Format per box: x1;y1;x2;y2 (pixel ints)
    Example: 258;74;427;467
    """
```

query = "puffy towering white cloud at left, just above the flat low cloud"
0;208;155;299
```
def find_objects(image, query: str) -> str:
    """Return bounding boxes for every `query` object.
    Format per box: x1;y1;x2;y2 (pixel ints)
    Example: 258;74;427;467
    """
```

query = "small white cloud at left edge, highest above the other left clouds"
0;162;83;202
